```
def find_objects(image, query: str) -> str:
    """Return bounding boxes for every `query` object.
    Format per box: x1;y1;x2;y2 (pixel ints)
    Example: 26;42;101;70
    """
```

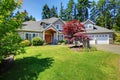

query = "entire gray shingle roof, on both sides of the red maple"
18;17;113;33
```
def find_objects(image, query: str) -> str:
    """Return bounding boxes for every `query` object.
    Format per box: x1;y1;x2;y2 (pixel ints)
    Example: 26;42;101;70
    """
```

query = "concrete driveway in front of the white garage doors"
93;44;120;54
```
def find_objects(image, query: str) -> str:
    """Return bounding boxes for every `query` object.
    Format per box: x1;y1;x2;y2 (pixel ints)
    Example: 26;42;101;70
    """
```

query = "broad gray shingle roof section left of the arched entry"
20;21;44;32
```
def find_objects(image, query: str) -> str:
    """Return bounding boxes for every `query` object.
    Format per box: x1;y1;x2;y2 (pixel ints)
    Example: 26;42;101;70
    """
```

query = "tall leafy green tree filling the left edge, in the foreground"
0;0;24;60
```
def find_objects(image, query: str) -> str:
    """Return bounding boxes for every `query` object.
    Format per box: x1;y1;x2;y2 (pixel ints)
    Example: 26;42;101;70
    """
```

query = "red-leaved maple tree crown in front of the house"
62;20;88;45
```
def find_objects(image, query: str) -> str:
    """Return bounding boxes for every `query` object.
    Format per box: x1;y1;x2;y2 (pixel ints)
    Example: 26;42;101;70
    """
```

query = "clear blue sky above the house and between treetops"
19;0;94;21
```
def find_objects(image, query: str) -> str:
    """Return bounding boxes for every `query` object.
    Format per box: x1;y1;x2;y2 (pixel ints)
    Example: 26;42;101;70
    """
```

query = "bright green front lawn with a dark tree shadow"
0;46;120;80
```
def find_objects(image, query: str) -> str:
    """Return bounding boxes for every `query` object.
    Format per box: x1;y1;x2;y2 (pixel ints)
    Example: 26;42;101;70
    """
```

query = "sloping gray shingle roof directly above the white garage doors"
86;25;113;33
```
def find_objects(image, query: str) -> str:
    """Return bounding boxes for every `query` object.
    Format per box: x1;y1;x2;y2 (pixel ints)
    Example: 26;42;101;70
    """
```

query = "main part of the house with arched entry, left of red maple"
18;17;64;44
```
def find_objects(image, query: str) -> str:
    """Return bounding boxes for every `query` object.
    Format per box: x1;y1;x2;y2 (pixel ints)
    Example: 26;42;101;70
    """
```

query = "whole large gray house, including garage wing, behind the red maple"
18;17;113;44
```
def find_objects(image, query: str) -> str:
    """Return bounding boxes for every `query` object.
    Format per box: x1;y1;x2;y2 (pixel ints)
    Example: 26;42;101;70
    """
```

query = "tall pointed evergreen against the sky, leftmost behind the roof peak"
42;4;50;19
